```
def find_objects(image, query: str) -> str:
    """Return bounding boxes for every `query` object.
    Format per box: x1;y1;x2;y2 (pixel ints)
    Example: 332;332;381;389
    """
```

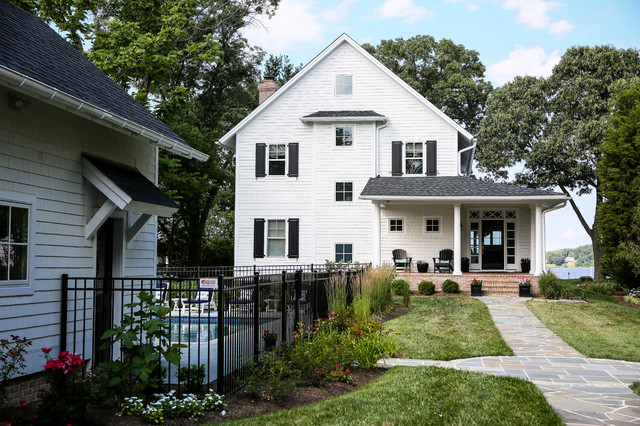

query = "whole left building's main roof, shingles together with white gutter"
0;0;209;161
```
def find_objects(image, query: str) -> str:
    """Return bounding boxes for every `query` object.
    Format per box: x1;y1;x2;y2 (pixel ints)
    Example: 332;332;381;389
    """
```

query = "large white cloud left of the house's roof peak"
244;0;326;52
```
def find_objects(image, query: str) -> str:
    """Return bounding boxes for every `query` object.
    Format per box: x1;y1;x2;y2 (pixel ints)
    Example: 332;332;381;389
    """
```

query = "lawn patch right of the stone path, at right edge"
527;292;640;362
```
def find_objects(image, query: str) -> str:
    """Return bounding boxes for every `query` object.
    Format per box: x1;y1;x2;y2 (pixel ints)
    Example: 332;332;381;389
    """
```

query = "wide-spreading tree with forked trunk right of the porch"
476;46;640;279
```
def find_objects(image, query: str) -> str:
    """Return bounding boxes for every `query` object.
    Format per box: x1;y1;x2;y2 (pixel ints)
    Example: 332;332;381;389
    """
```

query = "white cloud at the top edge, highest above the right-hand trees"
502;0;573;37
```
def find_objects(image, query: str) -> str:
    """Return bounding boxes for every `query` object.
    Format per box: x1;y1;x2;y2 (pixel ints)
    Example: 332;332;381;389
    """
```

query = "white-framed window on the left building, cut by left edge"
0;203;29;282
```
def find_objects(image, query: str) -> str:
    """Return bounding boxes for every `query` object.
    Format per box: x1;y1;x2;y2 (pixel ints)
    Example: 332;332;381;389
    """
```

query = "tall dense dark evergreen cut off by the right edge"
597;79;640;287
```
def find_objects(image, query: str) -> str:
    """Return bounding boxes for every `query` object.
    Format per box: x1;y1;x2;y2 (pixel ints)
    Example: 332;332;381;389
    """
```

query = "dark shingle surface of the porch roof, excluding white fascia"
360;176;564;198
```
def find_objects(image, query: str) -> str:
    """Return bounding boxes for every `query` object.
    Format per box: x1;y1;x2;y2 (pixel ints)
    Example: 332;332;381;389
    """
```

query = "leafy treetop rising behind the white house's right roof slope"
362;35;492;134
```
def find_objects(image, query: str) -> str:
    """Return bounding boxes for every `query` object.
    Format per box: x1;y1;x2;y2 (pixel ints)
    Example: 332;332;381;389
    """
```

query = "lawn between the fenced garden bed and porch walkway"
385;296;513;361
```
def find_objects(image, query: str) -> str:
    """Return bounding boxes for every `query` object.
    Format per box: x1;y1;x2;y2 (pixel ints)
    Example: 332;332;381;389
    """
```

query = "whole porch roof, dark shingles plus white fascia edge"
360;176;569;208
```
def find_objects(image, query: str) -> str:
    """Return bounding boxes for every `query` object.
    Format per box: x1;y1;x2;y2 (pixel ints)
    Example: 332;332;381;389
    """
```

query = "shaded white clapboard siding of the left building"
0;88;156;373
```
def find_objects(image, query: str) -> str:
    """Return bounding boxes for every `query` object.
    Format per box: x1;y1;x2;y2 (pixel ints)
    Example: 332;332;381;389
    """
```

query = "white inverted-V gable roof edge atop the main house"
220;33;473;150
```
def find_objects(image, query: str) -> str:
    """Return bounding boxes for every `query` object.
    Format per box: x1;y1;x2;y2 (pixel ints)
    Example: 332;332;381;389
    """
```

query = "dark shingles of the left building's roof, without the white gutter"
0;0;189;150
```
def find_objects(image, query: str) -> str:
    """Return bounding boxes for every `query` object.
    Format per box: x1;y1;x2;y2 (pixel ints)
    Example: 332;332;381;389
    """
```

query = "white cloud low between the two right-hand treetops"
487;45;560;86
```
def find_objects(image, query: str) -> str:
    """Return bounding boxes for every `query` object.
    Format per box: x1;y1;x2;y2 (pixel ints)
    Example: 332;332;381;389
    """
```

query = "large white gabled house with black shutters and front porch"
220;34;568;275
